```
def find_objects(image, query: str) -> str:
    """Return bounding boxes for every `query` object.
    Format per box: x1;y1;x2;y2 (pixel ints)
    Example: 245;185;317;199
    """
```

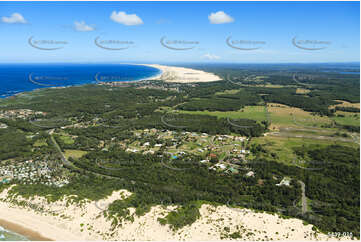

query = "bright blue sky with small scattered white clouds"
0;2;360;63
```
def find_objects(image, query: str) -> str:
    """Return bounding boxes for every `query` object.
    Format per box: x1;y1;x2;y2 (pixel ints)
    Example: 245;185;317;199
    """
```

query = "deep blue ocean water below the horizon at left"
0;64;160;98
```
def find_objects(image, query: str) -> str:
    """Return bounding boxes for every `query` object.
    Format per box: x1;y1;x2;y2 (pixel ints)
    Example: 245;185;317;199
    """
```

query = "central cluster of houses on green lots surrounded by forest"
116;129;254;176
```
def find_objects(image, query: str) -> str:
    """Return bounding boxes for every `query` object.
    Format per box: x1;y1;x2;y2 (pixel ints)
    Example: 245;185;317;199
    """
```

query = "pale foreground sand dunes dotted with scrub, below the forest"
0;186;346;241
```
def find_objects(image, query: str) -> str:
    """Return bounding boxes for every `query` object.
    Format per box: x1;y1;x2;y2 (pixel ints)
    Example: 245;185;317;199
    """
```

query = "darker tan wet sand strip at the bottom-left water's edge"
0;218;54;241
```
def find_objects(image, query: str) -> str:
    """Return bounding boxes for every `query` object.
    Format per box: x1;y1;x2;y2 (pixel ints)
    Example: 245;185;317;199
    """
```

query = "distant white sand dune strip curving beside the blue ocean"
144;64;222;83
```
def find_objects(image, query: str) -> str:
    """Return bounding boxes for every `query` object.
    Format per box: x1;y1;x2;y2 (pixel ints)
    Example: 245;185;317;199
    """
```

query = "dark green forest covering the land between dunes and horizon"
0;65;360;238
